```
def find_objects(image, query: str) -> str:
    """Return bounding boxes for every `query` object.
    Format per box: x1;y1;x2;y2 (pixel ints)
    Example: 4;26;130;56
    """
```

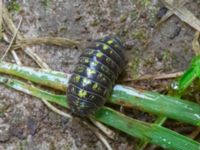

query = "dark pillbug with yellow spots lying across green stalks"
67;36;125;117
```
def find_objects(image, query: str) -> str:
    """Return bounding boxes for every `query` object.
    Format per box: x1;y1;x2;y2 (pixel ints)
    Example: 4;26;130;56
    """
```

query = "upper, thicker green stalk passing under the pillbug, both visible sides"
0;62;200;126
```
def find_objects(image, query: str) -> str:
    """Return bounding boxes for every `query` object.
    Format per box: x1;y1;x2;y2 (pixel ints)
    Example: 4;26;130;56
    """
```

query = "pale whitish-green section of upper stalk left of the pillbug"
0;62;70;91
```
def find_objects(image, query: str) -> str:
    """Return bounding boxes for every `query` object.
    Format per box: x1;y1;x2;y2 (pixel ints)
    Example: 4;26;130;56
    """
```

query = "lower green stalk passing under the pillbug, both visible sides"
0;76;200;150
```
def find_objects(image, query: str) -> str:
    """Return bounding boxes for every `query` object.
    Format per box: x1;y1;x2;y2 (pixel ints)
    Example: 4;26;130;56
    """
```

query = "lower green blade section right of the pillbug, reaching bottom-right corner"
94;107;200;150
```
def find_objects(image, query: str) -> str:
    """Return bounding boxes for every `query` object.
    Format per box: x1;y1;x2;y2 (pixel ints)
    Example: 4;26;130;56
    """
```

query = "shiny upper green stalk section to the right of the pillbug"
109;85;200;126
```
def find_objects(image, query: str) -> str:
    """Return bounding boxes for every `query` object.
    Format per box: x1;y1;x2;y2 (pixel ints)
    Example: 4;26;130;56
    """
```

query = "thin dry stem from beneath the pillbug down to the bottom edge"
83;121;112;150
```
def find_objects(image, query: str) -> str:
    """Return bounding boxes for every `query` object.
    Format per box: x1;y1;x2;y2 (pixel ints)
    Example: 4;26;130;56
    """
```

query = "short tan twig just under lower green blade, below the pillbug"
89;118;115;140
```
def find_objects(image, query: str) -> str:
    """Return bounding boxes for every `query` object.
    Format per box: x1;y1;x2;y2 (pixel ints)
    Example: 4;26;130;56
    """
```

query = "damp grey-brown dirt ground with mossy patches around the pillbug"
0;0;200;150
